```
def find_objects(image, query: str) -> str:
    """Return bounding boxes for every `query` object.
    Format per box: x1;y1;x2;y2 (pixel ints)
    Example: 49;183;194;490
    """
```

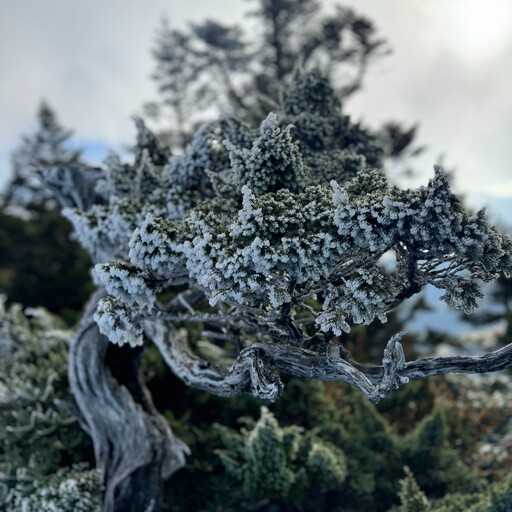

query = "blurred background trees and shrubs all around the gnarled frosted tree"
0;0;512;512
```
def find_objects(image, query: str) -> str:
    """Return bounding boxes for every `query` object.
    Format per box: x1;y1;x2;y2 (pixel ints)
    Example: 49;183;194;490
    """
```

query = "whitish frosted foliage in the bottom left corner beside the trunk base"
6;465;102;512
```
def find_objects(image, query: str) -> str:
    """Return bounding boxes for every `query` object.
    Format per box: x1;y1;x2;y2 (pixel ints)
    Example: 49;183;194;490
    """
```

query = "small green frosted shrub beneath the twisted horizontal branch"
214;407;347;508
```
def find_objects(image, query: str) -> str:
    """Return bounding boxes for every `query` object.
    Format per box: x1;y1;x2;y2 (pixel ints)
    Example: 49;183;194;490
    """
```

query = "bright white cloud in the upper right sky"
342;0;512;198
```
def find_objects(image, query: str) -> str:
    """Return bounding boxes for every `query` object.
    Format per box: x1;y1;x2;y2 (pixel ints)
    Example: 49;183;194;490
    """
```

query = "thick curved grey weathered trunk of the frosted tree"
69;291;189;512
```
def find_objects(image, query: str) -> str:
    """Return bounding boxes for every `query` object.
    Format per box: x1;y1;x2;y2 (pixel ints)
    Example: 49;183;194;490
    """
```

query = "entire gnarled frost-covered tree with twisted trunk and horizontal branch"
47;70;512;511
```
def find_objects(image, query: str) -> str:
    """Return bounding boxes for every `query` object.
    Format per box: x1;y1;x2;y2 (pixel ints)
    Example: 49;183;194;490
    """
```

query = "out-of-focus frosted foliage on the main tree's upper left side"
64;116;251;261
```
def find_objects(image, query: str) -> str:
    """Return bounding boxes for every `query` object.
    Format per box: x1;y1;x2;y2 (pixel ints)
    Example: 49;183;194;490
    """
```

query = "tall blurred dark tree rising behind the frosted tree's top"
146;0;387;148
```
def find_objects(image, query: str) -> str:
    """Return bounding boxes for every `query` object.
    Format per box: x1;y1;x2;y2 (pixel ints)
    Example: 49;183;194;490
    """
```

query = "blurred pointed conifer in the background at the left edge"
0;102;93;324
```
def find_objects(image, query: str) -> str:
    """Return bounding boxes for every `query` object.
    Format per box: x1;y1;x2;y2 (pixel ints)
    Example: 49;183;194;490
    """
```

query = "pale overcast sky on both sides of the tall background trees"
0;0;512;219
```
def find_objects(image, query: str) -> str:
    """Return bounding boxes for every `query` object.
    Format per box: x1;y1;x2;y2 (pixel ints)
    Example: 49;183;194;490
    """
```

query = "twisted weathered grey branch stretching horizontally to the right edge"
146;321;512;403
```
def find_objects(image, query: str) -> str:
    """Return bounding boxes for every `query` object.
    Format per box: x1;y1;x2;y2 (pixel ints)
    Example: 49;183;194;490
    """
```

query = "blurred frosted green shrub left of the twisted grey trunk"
0;304;92;510
